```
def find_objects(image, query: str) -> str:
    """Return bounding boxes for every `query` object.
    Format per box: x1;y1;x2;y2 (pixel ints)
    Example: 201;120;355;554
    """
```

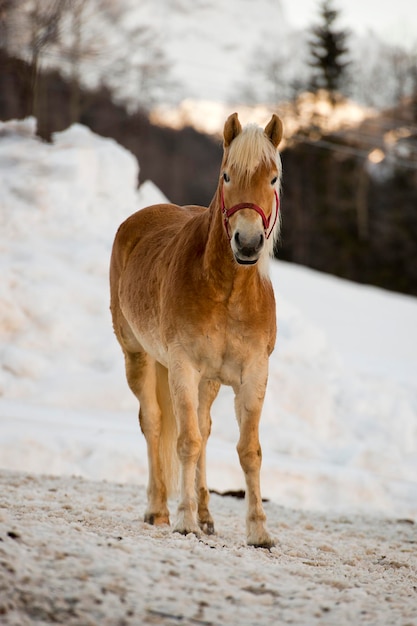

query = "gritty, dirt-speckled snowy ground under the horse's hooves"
0;472;417;626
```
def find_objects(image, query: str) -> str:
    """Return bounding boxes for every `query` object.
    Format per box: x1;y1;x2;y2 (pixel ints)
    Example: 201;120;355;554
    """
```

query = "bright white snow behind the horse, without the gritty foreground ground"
0;120;417;517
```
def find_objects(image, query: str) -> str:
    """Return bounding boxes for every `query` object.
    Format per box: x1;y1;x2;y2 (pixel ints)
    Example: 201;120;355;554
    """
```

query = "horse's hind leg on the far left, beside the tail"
124;350;169;524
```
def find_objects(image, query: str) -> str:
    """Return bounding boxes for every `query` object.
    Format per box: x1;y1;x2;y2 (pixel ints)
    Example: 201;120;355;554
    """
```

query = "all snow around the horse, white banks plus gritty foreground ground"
0;119;417;625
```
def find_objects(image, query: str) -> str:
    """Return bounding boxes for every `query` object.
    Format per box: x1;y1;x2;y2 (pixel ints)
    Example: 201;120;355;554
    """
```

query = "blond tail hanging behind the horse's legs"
156;363;180;497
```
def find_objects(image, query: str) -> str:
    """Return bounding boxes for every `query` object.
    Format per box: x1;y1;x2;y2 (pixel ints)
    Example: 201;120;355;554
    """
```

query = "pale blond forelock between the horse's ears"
226;124;281;185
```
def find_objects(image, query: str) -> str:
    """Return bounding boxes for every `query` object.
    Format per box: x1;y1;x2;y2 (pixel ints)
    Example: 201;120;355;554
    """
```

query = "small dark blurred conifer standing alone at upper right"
308;0;349;95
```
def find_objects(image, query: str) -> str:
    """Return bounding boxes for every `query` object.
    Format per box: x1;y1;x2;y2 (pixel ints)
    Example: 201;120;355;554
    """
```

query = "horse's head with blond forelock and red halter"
220;113;282;271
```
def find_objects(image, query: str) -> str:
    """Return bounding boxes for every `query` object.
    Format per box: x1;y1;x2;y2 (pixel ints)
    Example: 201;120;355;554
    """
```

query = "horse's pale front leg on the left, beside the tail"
169;357;202;535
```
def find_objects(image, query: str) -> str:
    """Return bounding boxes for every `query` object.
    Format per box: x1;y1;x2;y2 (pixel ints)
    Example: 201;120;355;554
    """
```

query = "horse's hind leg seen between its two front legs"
196;380;220;535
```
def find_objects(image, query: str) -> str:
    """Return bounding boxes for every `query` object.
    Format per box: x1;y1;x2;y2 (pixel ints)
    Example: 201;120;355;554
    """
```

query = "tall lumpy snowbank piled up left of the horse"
0;119;163;408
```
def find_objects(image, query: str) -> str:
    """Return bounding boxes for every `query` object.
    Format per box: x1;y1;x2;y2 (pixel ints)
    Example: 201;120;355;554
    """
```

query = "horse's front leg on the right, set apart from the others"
235;362;274;548
